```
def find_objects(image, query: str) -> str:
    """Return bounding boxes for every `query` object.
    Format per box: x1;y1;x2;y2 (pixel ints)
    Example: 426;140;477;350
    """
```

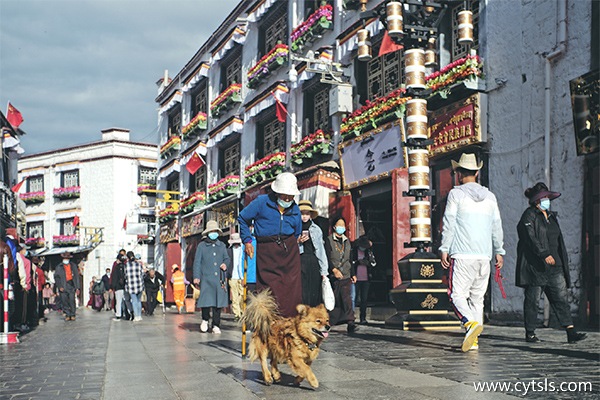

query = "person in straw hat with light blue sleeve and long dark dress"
298;200;329;307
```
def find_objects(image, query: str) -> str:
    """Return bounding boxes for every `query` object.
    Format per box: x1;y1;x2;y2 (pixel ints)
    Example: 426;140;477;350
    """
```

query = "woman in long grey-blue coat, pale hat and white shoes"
194;220;231;334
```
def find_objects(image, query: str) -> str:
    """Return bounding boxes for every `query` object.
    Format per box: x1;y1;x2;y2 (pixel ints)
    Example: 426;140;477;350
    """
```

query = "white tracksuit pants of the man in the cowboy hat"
448;258;490;324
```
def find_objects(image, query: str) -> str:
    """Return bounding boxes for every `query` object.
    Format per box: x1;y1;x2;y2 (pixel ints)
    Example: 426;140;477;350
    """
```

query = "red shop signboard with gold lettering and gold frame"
429;94;486;156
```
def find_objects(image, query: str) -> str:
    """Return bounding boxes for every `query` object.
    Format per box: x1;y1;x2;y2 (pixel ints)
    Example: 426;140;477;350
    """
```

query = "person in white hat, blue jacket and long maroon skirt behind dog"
238;172;302;317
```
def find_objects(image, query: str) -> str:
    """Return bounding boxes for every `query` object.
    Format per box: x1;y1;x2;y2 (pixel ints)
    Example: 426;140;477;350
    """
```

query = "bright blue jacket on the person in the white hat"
238;194;302;243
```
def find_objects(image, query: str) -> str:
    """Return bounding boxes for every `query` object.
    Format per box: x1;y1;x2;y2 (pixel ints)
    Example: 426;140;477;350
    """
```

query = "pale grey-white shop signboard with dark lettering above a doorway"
339;119;406;189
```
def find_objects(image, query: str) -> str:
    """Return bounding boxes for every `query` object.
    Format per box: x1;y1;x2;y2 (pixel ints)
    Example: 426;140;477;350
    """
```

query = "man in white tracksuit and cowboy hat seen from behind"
439;154;505;351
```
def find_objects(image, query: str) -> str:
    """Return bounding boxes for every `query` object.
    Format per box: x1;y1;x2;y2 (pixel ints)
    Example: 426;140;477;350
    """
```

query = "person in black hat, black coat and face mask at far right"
516;182;586;343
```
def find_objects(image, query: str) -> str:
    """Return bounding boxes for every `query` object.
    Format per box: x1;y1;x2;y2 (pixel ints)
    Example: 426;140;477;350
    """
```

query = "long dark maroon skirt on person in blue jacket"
256;235;302;317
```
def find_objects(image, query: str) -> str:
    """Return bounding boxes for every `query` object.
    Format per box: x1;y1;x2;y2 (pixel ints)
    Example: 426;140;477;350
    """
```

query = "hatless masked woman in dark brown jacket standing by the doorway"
325;218;358;333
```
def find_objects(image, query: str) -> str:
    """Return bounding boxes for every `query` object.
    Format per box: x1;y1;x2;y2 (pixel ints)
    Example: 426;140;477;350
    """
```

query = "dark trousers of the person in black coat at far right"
523;268;573;332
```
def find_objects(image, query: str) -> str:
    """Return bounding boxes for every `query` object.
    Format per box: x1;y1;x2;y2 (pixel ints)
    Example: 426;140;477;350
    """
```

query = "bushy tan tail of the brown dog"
241;289;281;343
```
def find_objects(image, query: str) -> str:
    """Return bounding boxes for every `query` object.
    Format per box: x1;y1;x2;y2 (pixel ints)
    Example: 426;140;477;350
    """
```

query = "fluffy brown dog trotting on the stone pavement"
243;290;330;388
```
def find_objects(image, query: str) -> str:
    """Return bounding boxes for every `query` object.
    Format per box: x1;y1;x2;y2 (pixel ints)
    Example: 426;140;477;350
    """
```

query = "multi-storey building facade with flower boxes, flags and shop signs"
156;0;598;328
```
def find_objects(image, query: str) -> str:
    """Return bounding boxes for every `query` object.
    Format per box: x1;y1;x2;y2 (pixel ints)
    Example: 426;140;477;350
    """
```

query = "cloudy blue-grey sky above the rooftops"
0;0;239;154
